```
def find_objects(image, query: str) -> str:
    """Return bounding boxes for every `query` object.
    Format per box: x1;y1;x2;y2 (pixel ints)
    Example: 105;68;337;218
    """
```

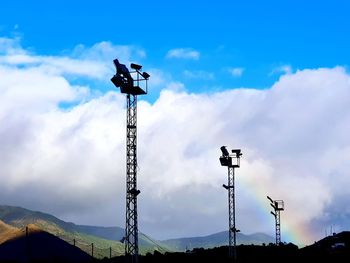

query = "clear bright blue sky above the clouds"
0;0;350;96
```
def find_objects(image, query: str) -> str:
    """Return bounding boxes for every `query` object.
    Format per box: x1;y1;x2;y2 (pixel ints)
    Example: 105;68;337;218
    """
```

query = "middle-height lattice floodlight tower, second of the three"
219;146;242;261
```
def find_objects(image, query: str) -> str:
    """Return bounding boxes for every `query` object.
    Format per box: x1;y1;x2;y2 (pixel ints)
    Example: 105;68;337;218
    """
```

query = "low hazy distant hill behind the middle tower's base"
161;231;274;251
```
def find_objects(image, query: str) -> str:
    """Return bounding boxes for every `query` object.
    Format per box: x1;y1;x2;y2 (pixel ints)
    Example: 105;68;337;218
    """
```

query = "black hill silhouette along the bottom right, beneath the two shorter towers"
106;241;350;263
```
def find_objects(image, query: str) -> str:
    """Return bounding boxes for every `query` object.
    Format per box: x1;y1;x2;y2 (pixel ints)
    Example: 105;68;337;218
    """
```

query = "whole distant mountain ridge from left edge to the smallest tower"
0;205;274;254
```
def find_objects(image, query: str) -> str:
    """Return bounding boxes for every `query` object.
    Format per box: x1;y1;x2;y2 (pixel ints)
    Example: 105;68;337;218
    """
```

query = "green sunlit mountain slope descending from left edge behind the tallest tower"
0;205;169;255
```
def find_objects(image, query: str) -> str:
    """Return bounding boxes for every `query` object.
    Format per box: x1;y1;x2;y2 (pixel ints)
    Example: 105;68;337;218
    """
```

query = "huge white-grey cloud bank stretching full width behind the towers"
0;36;350;246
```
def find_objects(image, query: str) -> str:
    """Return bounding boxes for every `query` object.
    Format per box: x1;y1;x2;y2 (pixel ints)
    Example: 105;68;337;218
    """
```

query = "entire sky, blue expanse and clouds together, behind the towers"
0;0;350;248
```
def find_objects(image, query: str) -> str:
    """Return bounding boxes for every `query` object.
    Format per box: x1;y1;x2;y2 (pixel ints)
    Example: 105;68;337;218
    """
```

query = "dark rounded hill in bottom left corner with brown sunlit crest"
0;225;92;263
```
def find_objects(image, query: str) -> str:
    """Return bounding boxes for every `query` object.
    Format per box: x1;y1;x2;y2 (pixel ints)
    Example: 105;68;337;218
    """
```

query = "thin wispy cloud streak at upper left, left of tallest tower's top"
0;38;146;80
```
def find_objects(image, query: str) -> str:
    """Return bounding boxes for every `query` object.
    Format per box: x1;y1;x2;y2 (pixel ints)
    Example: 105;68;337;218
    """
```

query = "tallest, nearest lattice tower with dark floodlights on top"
111;59;150;263
